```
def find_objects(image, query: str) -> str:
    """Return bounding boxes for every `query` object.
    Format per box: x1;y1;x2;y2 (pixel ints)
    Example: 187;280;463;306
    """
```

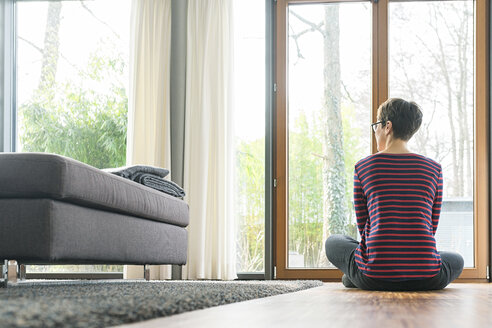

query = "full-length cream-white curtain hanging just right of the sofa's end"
183;0;237;280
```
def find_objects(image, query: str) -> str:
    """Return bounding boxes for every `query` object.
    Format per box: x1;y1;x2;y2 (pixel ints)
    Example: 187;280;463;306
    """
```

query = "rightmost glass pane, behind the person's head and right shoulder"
389;1;474;267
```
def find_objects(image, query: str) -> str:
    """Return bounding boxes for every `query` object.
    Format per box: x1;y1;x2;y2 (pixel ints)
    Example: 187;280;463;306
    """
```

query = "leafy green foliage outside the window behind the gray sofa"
19;50;128;168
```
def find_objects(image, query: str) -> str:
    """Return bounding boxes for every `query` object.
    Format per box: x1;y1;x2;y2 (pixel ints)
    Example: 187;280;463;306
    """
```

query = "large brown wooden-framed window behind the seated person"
275;0;489;279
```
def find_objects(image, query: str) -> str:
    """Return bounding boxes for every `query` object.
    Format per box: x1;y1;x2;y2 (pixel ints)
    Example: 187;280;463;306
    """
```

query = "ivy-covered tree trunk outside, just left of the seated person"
320;5;347;265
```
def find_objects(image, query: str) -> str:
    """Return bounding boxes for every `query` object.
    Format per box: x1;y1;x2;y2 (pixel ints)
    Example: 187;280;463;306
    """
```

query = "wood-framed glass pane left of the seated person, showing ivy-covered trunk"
288;2;372;268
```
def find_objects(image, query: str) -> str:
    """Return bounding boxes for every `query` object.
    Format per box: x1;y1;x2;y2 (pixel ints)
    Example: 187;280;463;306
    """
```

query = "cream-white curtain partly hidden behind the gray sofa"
124;0;172;279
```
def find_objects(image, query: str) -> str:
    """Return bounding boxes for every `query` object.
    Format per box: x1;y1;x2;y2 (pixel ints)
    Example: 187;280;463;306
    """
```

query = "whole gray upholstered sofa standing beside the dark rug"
0;153;189;284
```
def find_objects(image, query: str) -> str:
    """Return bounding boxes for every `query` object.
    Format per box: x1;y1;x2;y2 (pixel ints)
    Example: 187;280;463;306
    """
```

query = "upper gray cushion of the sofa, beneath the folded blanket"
0;153;189;227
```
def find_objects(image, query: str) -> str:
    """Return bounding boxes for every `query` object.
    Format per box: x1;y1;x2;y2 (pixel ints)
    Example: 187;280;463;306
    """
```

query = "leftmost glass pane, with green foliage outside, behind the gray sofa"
17;0;130;272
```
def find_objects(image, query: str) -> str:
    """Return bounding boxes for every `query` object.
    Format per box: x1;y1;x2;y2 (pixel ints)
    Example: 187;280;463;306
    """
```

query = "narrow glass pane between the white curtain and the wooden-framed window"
234;0;265;272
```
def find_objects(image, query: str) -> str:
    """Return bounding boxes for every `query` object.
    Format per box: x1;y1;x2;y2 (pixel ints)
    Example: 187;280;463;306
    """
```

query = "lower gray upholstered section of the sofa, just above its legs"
0;198;188;264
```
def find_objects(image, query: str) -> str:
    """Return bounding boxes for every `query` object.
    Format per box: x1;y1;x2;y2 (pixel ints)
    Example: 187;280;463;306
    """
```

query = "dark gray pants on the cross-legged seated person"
325;235;464;291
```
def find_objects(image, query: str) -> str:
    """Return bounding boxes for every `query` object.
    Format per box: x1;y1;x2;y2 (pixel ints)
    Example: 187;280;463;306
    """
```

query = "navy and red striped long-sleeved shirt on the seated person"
354;153;442;281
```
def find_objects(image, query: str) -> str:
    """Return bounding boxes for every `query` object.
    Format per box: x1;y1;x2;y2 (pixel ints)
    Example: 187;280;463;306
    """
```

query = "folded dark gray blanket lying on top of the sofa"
103;165;185;198
